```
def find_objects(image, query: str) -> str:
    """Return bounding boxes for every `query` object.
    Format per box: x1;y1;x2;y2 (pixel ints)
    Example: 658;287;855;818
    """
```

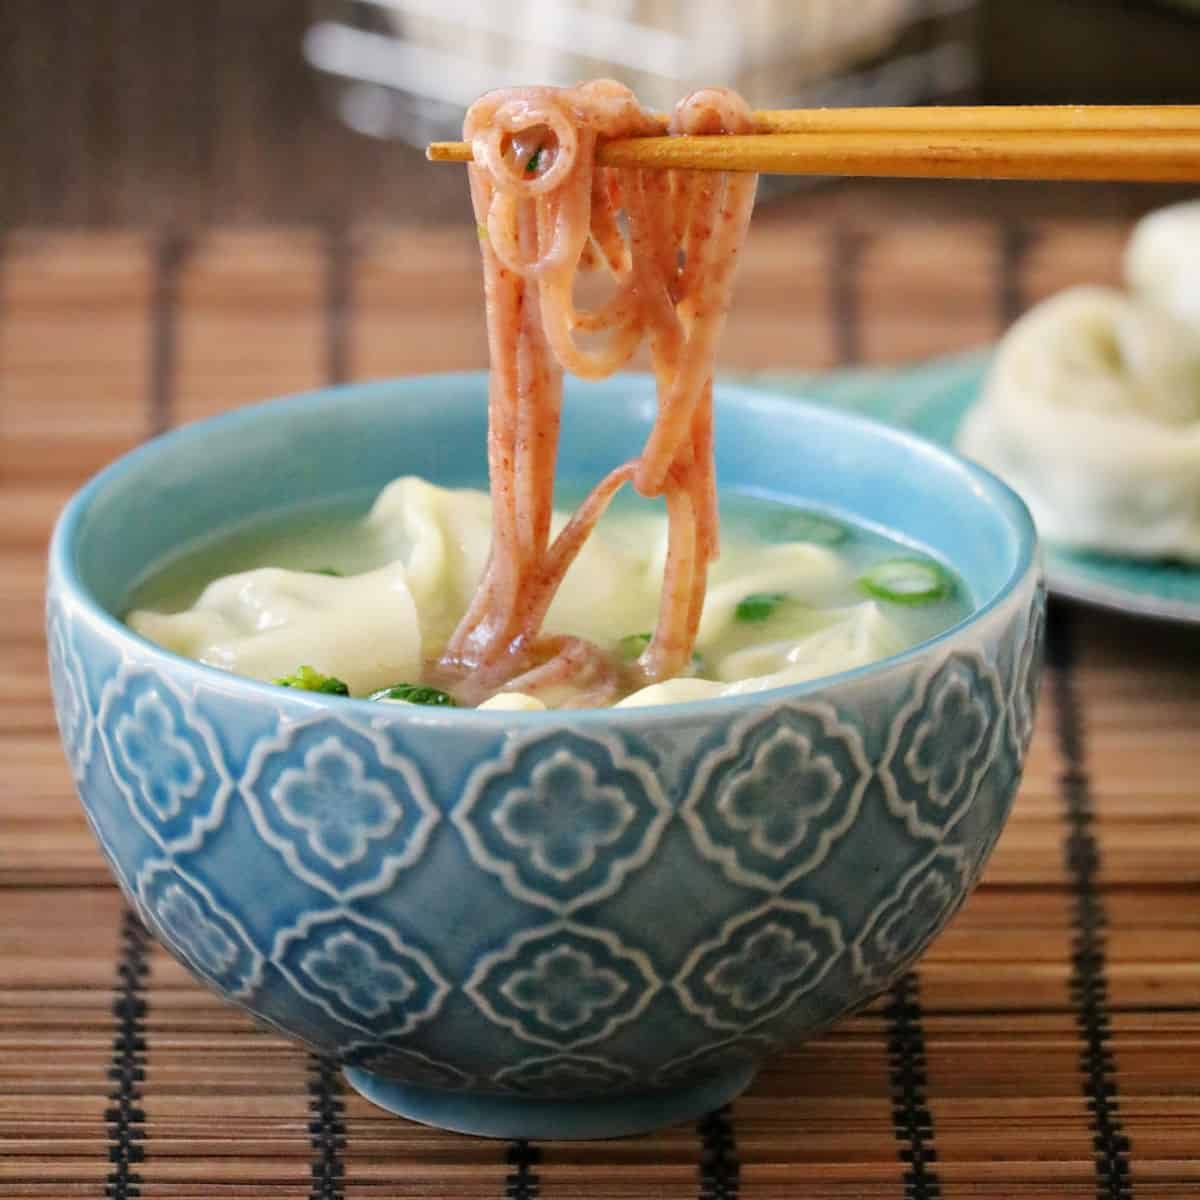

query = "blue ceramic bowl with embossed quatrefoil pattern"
47;374;1044;1136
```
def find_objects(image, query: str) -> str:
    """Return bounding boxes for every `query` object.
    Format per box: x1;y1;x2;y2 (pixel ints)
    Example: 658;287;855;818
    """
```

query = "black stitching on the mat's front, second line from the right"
883;971;942;1200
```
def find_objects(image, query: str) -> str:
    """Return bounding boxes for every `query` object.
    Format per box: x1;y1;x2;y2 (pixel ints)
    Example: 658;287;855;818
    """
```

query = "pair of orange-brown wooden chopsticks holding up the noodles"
426;104;1200;182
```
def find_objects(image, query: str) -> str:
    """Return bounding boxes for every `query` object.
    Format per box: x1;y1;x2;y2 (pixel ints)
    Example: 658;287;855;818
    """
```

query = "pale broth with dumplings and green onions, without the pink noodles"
128;478;971;709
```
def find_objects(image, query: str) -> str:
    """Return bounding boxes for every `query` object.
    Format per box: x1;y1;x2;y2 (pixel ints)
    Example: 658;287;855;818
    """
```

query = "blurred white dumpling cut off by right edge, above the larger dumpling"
1124;200;1200;335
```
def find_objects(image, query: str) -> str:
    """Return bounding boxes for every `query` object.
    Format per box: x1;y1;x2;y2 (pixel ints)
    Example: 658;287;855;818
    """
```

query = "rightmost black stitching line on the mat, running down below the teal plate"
1048;604;1133;1200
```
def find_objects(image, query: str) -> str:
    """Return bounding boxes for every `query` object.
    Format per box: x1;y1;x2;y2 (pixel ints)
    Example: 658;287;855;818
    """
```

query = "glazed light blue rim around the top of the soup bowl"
47;370;1040;731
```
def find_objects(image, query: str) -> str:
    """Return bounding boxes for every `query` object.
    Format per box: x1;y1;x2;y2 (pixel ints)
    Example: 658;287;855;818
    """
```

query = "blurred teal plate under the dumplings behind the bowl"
742;352;1200;624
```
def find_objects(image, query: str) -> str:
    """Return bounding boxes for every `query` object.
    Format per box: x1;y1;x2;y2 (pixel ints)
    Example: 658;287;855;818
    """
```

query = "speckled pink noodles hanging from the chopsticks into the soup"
441;79;756;703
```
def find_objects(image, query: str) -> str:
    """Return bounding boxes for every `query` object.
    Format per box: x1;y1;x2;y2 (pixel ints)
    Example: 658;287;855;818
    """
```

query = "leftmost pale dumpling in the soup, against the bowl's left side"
126;563;421;696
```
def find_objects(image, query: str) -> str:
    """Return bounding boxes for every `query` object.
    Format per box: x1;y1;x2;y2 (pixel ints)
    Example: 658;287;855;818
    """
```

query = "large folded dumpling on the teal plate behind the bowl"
958;288;1200;562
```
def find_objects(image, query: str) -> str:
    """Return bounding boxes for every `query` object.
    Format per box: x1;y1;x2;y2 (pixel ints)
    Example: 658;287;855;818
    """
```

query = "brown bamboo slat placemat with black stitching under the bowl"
0;220;1200;1200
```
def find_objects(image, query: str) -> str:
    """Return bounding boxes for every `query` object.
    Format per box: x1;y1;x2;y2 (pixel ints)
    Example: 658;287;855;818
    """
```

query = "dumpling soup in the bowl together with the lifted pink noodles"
130;79;967;709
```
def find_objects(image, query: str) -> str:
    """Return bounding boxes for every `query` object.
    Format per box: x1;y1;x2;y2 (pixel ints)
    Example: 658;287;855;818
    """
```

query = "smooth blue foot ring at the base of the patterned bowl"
346;1063;758;1139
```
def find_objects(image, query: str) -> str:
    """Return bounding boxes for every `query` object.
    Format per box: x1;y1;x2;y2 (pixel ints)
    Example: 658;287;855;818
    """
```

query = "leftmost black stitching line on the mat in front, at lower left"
104;908;150;1200
